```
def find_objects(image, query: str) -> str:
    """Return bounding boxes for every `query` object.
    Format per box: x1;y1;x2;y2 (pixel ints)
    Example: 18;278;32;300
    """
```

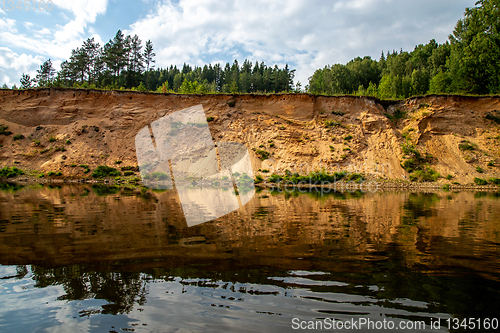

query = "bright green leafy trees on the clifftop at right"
308;0;500;98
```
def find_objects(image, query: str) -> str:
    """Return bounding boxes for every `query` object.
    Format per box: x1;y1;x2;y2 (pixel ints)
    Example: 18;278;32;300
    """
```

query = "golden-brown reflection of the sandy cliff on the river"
0;186;500;278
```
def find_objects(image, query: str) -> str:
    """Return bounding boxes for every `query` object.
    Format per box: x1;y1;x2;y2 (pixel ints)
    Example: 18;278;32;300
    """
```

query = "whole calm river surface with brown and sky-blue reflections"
0;184;500;332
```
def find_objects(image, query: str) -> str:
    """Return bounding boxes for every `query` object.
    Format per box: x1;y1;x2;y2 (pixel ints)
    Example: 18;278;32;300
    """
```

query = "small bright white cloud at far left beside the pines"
0;47;45;87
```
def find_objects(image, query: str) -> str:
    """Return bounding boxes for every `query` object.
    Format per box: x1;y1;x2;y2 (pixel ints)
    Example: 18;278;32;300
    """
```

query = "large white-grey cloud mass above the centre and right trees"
126;0;475;85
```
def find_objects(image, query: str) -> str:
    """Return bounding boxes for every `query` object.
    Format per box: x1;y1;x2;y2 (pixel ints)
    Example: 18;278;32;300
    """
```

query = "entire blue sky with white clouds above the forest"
0;0;476;86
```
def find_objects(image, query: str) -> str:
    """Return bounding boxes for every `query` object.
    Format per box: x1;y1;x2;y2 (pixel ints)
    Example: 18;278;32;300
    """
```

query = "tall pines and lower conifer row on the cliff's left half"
13;30;295;93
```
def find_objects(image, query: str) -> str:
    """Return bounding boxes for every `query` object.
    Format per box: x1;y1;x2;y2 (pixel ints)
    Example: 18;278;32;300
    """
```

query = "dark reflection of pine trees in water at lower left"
32;265;148;315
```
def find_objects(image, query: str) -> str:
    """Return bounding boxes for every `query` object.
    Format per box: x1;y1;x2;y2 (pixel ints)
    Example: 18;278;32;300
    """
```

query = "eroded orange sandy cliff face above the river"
0;89;500;184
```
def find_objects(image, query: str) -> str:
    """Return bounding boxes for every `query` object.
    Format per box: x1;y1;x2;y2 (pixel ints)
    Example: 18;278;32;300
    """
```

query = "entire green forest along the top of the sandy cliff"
4;0;500;99
